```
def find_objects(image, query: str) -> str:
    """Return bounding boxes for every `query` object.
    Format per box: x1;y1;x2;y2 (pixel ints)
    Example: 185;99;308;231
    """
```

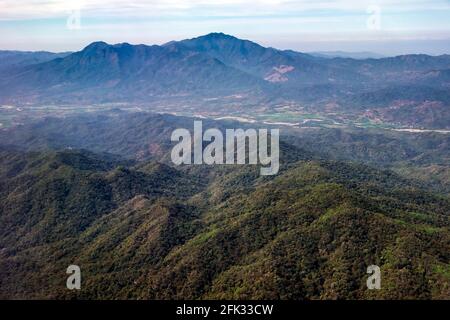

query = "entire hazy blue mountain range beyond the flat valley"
0;33;450;128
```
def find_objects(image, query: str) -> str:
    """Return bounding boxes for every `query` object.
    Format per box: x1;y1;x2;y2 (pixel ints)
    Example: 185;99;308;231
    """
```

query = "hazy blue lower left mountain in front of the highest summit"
0;38;264;102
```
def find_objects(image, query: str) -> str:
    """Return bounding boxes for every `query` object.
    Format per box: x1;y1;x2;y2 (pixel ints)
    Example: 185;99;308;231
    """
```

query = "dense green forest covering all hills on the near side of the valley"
0;115;450;299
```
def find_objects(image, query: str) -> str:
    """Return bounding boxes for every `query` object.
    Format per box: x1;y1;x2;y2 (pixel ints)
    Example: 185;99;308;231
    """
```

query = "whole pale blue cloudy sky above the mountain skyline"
0;0;450;55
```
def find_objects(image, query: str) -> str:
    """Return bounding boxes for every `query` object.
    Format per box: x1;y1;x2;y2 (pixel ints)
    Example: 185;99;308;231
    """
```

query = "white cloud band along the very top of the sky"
0;0;450;20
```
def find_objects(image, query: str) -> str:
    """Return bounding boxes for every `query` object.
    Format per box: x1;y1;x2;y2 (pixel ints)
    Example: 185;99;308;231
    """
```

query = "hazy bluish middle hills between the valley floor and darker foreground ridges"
0;110;450;194
